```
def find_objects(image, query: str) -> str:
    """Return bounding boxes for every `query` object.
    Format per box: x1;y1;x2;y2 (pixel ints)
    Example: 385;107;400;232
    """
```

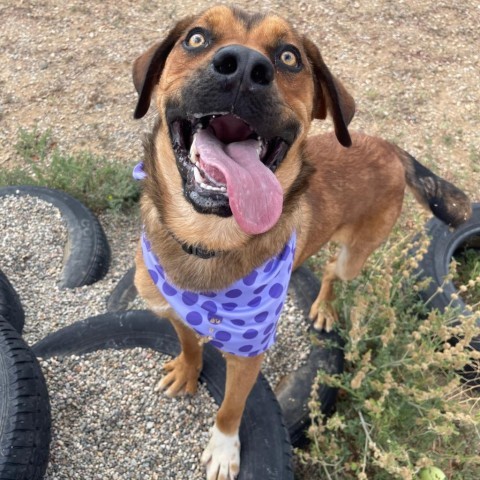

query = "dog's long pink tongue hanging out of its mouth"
195;129;283;235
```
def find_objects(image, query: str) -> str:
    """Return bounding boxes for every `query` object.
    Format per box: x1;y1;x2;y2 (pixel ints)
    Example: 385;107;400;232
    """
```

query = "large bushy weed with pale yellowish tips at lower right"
298;232;480;480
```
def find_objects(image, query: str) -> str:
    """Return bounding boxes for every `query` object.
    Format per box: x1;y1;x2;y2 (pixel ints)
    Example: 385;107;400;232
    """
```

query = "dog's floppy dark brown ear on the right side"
303;38;355;147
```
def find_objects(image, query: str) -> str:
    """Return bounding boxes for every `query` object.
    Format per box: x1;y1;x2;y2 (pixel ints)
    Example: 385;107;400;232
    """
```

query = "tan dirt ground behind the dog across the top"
0;0;480;201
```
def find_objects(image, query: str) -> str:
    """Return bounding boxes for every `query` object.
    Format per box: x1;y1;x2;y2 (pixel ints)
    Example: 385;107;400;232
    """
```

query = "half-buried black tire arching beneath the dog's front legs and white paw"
32;310;293;480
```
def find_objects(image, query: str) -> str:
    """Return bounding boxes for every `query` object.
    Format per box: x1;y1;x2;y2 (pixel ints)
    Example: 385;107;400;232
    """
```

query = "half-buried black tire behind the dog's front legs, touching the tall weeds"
107;266;344;447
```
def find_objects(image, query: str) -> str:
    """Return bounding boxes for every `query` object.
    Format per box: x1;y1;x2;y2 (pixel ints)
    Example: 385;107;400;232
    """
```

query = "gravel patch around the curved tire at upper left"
0;197;139;345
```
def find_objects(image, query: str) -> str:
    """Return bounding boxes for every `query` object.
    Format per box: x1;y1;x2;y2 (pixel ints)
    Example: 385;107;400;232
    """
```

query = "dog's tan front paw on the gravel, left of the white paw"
155;354;202;397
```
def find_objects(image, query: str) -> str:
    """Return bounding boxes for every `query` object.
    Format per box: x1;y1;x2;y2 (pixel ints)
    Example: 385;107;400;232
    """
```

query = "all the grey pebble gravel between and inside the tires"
0;196;310;480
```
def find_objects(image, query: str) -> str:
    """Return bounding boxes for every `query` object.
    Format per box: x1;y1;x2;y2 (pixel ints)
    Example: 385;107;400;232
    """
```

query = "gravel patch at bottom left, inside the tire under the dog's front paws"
41;348;217;480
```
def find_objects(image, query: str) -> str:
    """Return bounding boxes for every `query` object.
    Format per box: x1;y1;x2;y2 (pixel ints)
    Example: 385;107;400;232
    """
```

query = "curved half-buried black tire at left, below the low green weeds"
0;185;110;288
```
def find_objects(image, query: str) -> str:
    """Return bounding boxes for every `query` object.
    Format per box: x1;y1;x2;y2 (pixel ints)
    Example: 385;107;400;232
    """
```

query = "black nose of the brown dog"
213;45;274;89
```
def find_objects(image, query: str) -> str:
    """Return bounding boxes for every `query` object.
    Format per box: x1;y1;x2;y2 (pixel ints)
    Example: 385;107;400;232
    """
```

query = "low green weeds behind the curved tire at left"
0;129;139;212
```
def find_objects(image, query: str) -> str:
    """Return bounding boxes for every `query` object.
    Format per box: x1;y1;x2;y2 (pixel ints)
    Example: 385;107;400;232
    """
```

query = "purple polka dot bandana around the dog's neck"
142;233;296;357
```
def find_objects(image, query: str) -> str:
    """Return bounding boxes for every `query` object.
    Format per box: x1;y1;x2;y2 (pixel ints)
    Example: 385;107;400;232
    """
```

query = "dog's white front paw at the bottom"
201;425;240;480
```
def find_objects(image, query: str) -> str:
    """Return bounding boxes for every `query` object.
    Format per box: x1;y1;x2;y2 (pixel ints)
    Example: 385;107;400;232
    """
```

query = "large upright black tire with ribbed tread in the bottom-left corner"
0;315;51;480
